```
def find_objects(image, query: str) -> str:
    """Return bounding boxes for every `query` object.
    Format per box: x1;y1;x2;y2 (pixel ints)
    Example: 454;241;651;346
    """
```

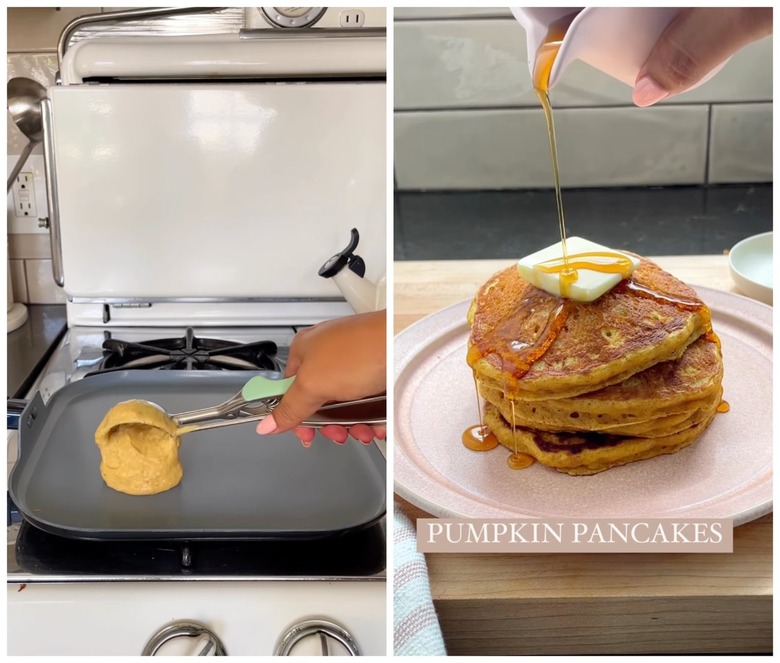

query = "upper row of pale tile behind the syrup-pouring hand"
394;19;772;110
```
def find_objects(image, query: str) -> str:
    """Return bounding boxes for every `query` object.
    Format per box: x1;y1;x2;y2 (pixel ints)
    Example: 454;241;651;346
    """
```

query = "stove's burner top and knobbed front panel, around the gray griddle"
7;327;386;655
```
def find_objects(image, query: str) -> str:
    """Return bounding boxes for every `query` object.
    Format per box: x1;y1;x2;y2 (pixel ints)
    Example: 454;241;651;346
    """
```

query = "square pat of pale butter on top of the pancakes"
517;237;639;302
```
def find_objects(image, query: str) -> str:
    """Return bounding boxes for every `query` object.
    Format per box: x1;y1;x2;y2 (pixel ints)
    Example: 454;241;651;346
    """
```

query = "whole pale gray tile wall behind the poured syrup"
394;14;772;189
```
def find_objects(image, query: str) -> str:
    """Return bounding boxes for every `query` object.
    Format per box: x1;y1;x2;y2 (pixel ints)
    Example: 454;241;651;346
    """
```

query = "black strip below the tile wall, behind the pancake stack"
395;184;772;260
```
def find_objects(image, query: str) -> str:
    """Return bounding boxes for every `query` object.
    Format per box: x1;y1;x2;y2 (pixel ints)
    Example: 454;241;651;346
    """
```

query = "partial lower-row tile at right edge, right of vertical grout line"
709;104;772;184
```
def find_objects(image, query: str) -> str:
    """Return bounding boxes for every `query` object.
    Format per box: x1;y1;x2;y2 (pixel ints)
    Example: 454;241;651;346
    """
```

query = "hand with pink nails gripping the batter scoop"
257;311;387;446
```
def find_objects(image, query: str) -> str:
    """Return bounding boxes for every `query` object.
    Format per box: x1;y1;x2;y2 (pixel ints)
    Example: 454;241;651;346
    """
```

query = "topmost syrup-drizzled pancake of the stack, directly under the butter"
467;258;710;401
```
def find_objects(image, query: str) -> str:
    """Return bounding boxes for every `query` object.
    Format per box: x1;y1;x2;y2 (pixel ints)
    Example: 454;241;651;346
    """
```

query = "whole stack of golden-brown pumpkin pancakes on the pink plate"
468;259;723;474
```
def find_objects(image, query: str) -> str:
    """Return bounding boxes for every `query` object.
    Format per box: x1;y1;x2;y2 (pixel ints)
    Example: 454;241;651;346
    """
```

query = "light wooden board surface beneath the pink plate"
394;255;772;655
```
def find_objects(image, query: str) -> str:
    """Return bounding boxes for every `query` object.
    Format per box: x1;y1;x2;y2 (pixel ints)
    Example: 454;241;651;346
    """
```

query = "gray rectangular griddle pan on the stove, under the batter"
9;371;386;540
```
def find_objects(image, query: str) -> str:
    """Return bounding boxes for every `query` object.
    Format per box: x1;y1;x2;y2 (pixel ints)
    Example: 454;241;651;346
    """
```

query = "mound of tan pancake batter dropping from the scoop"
95;400;183;495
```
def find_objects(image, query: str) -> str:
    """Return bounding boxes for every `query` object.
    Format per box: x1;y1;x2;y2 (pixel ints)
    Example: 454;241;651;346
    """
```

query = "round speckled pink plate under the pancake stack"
394;287;772;526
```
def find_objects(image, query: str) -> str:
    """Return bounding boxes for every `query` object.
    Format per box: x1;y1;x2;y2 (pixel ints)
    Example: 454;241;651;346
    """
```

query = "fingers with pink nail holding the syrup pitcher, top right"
633;7;772;107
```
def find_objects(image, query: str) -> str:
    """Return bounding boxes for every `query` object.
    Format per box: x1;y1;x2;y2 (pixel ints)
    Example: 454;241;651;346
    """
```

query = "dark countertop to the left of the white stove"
7;304;68;398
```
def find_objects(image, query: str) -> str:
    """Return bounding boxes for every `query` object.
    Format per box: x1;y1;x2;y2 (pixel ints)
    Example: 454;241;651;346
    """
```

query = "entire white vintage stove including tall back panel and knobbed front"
8;8;387;655
